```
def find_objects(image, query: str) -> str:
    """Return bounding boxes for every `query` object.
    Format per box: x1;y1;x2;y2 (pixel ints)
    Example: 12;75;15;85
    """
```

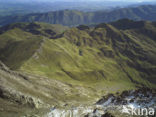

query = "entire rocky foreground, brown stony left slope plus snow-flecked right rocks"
0;62;156;117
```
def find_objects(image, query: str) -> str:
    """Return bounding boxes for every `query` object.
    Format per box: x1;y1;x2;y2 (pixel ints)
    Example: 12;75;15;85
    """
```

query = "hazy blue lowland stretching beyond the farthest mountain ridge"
0;0;140;16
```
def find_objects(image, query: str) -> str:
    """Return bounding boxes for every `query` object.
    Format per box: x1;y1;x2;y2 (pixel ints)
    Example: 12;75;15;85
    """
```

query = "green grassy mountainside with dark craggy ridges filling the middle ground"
0;20;156;90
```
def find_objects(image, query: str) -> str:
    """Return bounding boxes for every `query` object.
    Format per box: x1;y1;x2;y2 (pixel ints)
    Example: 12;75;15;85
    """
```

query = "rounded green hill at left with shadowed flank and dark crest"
0;24;66;69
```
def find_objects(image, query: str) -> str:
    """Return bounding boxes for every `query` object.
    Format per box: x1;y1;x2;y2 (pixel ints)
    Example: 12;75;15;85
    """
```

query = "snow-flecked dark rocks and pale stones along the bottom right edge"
47;88;156;117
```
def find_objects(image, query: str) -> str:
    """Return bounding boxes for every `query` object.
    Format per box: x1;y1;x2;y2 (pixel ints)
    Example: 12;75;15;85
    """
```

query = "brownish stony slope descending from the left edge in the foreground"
0;61;96;117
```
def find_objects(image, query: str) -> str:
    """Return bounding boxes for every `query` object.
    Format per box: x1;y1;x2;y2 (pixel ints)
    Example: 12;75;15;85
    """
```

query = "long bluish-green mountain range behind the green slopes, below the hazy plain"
0;5;156;26
